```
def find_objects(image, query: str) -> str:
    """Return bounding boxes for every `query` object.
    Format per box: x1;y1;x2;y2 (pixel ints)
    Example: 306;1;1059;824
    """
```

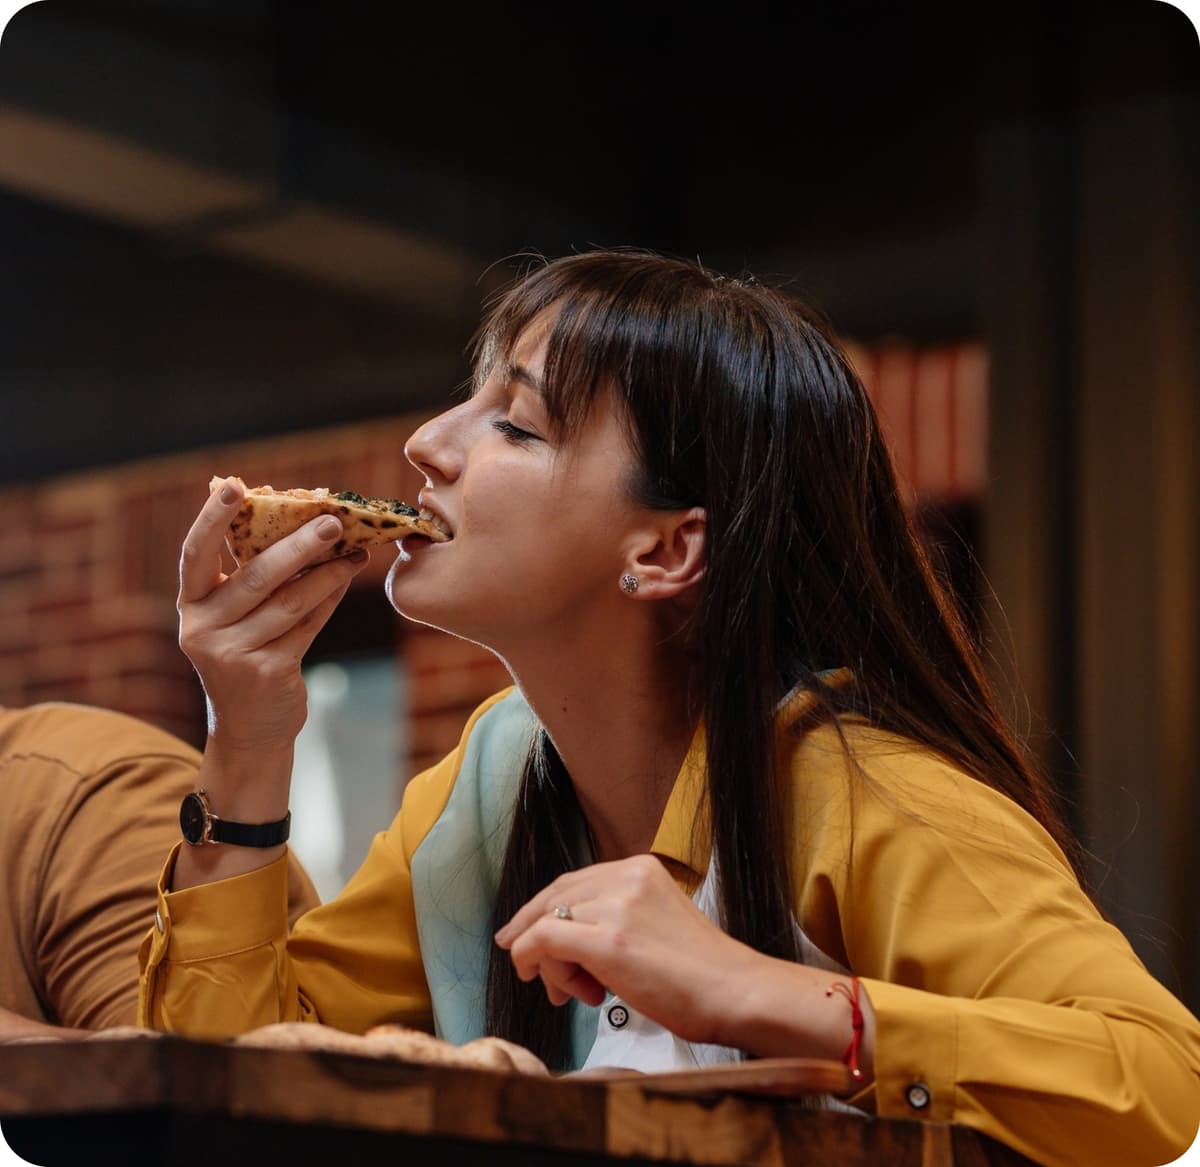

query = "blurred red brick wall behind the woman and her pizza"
0;345;986;773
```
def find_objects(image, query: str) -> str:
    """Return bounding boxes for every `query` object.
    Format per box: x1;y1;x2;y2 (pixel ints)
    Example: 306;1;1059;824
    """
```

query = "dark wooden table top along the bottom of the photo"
0;1037;1028;1167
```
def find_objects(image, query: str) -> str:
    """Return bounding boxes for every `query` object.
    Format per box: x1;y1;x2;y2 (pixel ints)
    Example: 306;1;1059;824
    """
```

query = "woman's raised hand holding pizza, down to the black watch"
178;481;367;850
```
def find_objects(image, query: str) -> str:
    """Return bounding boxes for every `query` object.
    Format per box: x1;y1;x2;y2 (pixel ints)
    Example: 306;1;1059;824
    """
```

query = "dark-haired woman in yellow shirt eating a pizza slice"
142;252;1200;1165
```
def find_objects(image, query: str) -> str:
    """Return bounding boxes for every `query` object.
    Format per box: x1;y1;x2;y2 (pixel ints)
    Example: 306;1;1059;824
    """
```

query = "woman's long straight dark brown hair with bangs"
474;251;1082;1066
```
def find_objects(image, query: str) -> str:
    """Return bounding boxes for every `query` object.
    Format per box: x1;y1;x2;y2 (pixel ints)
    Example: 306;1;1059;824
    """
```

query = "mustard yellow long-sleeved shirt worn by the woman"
139;692;1200;1167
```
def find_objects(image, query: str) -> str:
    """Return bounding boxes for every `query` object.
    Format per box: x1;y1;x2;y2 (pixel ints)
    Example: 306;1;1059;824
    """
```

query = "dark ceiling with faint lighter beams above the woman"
0;0;1200;481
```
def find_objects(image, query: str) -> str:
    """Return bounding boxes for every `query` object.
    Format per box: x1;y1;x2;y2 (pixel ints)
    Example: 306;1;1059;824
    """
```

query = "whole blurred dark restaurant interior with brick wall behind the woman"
0;0;1200;1010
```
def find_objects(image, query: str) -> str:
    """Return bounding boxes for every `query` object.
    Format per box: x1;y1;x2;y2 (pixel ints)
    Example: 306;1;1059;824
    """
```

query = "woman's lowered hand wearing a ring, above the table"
496;855;768;1042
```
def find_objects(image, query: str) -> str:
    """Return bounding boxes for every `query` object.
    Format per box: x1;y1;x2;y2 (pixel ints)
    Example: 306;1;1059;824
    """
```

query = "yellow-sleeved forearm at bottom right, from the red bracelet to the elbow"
864;969;1200;1167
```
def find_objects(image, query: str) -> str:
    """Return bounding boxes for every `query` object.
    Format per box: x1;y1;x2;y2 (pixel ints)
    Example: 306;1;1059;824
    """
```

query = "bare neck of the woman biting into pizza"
508;636;696;861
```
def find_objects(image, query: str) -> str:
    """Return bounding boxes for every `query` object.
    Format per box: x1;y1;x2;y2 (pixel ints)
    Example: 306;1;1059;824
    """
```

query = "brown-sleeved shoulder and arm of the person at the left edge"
0;704;318;1040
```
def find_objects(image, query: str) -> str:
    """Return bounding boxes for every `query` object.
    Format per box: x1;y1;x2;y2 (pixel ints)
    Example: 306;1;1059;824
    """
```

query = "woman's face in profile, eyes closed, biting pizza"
388;316;646;658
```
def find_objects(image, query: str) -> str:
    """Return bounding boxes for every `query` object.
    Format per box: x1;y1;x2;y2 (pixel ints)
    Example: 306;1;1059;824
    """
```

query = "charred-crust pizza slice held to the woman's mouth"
209;477;450;564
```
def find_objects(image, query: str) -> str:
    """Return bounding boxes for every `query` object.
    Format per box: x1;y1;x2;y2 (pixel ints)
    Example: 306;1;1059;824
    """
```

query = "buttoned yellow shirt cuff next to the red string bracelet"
859;977;958;1123
